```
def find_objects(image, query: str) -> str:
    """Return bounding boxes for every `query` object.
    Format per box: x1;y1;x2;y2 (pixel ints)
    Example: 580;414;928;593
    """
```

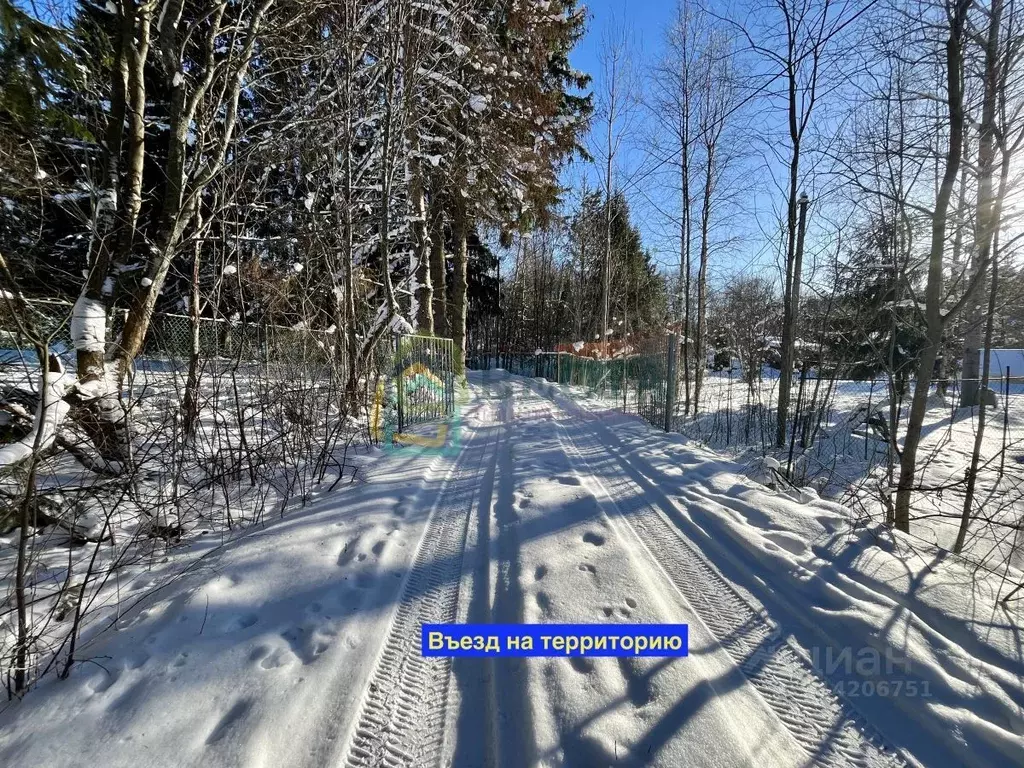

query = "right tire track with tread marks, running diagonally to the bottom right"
535;386;907;768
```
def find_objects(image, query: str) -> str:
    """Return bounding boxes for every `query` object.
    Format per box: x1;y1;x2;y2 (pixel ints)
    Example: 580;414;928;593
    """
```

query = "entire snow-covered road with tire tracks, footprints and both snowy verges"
0;372;1024;768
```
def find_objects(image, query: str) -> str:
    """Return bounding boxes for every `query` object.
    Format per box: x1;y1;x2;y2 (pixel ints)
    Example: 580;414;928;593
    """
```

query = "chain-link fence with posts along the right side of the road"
471;337;1024;567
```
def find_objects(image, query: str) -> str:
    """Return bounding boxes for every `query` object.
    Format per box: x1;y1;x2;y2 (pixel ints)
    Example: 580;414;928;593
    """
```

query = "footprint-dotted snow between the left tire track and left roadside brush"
0;442;429;767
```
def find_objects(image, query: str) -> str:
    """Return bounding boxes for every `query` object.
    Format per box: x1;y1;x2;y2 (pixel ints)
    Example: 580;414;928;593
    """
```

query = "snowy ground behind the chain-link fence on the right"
655;367;1024;570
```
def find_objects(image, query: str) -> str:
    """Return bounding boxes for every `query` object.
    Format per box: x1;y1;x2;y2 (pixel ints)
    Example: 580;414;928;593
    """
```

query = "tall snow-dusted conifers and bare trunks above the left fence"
0;0;591;397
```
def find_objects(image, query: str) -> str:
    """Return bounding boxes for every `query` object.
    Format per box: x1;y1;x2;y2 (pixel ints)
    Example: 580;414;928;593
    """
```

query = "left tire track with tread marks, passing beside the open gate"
344;397;503;768
